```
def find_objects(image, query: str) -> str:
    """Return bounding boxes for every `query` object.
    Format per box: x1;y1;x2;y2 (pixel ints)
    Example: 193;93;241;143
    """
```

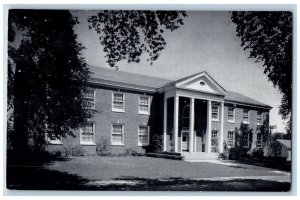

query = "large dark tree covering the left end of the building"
8;10;92;159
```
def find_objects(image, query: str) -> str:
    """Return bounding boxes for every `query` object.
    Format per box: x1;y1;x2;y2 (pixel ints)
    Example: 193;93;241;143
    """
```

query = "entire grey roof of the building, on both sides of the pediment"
89;66;271;108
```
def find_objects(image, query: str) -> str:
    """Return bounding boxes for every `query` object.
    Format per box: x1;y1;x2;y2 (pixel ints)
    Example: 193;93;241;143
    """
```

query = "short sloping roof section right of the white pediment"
225;91;271;108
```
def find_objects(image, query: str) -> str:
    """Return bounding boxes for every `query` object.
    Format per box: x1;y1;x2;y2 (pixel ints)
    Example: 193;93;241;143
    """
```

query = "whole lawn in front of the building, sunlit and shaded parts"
7;156;290;191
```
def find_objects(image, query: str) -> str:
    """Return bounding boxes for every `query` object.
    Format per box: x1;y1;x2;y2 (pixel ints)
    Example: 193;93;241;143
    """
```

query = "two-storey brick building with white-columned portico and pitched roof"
48;67;271;160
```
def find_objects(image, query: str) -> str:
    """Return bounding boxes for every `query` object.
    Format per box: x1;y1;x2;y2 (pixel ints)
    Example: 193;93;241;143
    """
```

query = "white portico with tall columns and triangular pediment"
163;72;226;153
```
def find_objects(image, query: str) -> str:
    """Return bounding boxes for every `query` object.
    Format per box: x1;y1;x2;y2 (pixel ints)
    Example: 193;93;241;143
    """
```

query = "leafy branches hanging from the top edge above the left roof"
88;10;187;67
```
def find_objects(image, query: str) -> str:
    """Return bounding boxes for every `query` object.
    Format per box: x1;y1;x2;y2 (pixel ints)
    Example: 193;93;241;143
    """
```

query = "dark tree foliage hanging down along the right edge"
231;12;292;134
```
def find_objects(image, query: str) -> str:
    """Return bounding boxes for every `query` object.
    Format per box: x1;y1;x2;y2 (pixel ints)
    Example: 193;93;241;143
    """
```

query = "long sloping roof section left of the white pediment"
90;66;171;88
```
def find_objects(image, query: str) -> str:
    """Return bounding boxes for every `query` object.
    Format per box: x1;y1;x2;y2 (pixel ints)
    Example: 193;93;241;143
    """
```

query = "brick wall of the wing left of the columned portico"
47;87;163;155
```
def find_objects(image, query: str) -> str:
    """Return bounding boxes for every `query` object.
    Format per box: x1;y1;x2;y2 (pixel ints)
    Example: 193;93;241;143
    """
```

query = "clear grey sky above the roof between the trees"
72;11;285;132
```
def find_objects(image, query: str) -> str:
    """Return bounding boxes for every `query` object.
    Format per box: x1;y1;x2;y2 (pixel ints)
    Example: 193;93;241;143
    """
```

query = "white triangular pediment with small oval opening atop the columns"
176;72;226;95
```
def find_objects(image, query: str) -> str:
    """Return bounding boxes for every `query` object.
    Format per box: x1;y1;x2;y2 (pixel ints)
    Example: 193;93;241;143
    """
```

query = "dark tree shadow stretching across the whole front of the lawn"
7;166;290;192
